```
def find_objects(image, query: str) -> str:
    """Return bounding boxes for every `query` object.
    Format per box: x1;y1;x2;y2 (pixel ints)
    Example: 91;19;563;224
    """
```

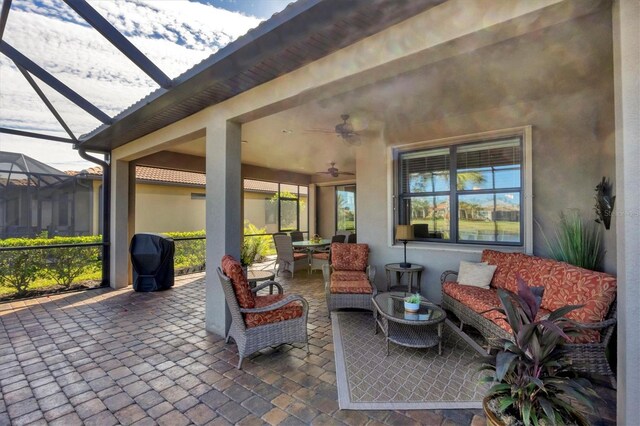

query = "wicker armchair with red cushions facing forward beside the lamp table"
322;243;378;314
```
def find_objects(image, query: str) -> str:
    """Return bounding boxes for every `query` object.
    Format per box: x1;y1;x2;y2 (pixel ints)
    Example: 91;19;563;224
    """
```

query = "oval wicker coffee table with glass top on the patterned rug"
373;292;447;355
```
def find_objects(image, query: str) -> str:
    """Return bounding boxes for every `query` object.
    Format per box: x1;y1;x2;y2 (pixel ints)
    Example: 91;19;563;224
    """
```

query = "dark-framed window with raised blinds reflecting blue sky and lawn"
398;137;523;245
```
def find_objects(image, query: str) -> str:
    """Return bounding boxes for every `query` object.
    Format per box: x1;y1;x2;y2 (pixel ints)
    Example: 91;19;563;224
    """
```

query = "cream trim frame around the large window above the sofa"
387;126;533;254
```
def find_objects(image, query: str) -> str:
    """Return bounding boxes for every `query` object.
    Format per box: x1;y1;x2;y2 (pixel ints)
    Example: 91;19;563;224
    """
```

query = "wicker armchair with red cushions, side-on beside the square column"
217;256;309;369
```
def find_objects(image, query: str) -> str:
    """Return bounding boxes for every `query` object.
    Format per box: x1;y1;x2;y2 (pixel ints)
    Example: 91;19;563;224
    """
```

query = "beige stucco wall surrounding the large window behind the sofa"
357;11;616;301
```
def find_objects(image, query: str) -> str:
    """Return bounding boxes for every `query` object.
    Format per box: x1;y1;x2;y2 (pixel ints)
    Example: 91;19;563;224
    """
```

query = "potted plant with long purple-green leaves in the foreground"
480;277;597;426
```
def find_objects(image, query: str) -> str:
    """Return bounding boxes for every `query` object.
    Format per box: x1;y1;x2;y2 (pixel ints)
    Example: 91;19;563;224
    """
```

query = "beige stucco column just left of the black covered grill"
109;160;135;288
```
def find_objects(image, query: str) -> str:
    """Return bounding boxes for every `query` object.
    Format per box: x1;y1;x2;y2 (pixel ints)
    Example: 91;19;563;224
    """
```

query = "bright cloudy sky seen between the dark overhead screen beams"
0;0;260;169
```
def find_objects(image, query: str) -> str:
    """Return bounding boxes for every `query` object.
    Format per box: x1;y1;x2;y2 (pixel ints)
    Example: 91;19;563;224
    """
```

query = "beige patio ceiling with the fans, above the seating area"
161;3;609;178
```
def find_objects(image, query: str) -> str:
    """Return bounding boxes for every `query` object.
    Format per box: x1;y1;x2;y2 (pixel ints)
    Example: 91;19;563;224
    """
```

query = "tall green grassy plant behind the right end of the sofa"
543;211;604;271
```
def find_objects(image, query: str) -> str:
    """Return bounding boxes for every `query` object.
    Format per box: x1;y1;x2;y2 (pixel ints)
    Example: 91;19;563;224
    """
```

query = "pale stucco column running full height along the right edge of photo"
613;0;640;425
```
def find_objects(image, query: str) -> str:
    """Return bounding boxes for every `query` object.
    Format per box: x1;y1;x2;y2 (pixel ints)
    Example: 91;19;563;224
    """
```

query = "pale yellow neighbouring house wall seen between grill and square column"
136;184;205;232
